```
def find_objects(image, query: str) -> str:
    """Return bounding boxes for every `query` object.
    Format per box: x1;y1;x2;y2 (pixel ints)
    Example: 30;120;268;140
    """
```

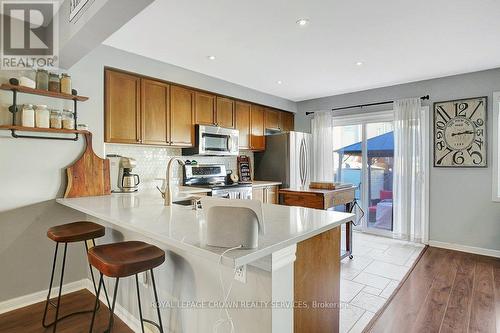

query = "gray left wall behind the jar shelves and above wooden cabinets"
0;46;296;302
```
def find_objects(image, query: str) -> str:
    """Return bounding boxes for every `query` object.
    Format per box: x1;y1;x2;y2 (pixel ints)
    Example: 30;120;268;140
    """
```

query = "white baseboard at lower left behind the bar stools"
0;279;87;314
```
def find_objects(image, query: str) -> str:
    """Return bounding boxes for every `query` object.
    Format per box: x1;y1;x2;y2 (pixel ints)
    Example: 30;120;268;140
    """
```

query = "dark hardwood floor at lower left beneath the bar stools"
0;290;133;333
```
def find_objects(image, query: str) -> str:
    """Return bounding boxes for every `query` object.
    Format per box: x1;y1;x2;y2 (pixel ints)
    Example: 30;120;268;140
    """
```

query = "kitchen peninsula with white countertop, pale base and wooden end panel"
57;191;353;332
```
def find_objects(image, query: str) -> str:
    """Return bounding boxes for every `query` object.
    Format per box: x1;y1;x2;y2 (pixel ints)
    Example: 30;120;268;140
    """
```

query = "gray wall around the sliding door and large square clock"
296;69;500;250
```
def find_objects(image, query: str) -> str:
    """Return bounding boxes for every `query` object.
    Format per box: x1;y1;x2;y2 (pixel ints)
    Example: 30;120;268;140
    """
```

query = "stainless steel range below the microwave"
183;164;252;199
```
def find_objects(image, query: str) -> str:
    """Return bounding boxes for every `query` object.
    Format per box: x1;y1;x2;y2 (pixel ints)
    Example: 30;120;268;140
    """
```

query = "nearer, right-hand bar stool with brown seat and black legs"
88;241;165;333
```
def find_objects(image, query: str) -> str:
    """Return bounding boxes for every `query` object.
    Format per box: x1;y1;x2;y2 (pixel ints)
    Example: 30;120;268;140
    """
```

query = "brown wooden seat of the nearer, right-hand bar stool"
88;241;165;277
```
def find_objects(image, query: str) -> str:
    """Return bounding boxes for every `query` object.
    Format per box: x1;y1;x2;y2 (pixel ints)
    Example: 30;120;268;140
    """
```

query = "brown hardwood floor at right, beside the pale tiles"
365;247;500;333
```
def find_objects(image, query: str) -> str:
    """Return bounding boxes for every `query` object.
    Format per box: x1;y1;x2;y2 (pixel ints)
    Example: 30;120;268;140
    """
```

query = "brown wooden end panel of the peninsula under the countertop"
293;227;340;333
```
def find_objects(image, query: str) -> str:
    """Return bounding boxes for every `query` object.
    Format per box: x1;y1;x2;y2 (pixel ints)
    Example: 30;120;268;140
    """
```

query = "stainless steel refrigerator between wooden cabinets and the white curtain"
254;132;312;188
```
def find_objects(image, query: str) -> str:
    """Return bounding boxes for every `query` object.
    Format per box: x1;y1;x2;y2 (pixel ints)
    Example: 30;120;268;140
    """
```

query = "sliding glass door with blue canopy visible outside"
333;112;394;235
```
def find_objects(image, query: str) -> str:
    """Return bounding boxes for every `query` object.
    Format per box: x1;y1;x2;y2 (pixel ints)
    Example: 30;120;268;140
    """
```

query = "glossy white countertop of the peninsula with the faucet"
57;191;354;267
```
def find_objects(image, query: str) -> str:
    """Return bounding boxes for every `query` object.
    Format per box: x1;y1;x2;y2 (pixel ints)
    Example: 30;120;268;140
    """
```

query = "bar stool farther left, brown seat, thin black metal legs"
42;221;109;332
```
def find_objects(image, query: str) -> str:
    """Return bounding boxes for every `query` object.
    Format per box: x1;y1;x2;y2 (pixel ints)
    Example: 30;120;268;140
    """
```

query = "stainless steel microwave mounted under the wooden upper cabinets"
182;125;239;156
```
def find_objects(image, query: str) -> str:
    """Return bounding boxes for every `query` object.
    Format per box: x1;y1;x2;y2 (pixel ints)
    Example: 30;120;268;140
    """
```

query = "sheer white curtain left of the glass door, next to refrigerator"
311;112;333;182
